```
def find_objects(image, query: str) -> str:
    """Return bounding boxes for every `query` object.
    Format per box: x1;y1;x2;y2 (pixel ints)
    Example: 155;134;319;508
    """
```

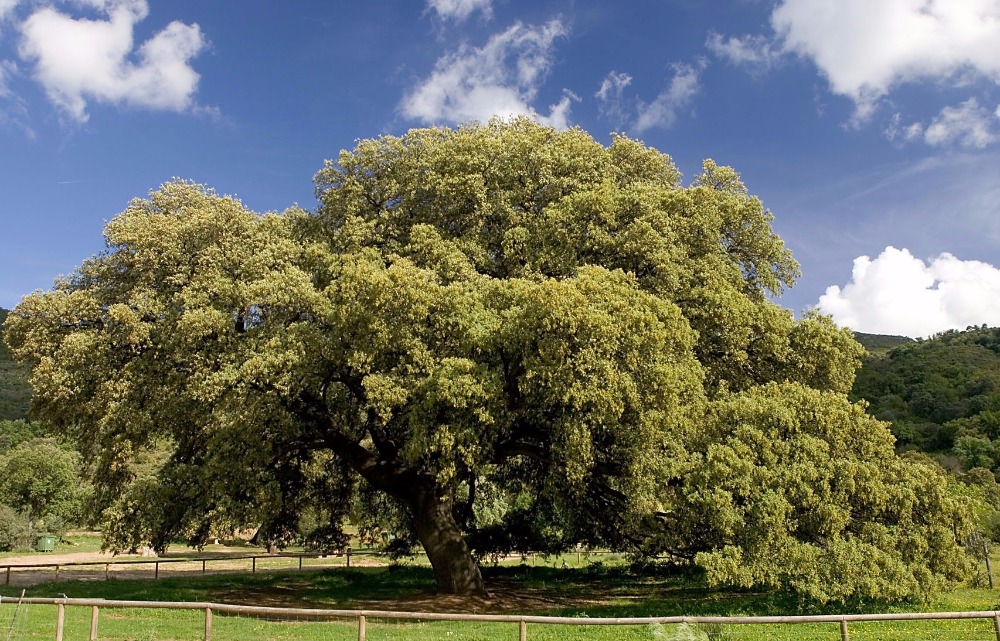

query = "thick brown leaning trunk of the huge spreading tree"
412;488;486;596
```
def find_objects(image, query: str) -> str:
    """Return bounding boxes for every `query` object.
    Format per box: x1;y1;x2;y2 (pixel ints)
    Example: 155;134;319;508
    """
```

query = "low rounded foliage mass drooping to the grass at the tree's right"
664;384;973;601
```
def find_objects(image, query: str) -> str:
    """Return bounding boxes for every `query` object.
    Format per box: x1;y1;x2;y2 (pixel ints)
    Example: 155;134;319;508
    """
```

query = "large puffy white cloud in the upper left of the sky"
19;0;206;122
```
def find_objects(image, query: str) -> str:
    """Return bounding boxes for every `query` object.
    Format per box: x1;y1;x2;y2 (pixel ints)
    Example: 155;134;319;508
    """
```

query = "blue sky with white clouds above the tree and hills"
0;0;1000;336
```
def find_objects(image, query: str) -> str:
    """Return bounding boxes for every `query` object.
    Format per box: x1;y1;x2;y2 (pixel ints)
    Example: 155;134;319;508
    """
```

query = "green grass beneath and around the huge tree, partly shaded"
0;555;998;641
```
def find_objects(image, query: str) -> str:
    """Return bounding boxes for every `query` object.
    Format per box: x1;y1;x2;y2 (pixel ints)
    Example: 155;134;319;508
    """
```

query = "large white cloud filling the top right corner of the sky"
771;0;1000;122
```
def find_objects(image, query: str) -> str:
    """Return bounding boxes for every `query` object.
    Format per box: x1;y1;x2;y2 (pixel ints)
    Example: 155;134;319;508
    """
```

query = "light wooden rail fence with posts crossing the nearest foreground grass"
0;597;1000;641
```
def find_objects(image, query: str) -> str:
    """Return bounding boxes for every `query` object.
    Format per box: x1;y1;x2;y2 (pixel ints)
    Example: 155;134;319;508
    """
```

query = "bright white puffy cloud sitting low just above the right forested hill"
818;247;1000;338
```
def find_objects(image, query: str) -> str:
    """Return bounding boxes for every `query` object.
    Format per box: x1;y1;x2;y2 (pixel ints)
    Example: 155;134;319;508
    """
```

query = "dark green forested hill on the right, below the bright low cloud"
852;325;1000;471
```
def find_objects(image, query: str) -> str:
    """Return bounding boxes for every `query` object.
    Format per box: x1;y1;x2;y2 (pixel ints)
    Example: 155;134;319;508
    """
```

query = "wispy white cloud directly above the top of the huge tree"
399;20;573;126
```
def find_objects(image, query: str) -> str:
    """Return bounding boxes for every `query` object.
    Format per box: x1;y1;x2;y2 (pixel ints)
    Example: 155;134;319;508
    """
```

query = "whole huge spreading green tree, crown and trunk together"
6;119;966;598
